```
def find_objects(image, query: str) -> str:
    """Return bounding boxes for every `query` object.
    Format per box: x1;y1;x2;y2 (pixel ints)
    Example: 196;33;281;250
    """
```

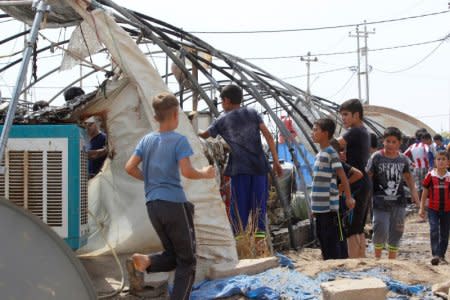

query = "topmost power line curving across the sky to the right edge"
190;10;449;34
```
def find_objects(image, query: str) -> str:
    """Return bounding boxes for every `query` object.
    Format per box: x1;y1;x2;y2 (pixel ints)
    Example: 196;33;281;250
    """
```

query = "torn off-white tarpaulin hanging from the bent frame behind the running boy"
66;1;237;263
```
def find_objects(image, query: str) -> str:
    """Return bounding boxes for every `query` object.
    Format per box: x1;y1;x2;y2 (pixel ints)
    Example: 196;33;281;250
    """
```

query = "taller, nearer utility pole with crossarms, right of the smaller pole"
349;20;375;104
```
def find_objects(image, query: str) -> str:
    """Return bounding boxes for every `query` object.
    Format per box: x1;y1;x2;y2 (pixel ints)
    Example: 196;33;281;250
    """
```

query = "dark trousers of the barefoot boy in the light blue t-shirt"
147;200;197;300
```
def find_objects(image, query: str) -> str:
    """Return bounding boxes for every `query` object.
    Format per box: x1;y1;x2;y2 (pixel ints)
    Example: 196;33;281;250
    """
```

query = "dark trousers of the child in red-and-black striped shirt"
428;209;450;258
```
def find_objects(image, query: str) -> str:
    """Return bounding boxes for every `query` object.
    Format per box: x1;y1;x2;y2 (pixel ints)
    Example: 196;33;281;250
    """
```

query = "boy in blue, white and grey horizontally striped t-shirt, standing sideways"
311;118;355;260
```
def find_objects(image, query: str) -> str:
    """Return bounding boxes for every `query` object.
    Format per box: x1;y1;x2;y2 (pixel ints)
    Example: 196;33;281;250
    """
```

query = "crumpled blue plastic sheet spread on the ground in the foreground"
191;264;430;300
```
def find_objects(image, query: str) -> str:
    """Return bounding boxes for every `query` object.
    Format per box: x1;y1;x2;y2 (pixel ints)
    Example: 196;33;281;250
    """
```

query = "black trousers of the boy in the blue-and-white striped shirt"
314;212;348;260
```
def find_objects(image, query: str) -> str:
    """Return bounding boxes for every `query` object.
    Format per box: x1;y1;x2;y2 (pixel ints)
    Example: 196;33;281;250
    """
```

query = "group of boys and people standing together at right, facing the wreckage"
311;99;450;265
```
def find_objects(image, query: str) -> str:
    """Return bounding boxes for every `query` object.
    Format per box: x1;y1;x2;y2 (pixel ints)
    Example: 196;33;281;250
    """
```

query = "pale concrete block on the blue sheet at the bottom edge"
320;278;388;300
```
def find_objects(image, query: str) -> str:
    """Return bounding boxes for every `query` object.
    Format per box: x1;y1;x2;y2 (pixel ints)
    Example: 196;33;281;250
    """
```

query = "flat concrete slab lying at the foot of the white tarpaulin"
206;256;279;279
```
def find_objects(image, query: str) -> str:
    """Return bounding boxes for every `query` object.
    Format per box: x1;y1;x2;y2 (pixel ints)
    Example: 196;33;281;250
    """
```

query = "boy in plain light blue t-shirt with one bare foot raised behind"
125;93;215;299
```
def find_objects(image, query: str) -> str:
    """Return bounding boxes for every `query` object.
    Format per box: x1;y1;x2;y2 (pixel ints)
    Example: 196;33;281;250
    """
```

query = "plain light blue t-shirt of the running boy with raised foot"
134;131;193;203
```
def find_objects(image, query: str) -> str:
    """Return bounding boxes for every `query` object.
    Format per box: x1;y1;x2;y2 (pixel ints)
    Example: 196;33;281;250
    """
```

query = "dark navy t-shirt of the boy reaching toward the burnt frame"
208;107;269;176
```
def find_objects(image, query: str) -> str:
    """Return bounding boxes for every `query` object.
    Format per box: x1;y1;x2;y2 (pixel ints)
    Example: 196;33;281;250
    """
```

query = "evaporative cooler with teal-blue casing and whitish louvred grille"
0;124;88;250
